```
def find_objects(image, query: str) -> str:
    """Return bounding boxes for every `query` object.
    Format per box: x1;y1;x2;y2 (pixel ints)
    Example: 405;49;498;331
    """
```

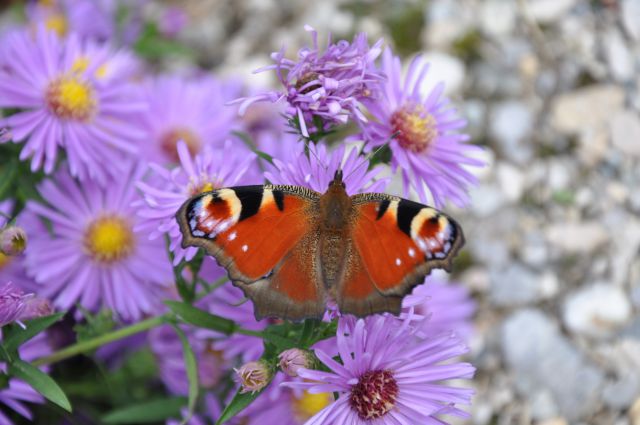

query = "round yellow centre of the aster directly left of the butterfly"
84;216;135;263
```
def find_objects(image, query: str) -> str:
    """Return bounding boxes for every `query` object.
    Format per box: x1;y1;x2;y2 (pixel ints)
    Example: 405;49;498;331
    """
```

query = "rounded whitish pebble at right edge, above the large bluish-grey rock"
563;283;632;338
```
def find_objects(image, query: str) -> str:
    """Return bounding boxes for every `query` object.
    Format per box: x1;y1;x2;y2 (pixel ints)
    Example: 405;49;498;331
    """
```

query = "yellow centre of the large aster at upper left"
46;74;97;121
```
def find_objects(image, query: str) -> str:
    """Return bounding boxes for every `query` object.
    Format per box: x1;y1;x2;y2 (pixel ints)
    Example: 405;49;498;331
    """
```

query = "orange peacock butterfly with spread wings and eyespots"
176;170;464;320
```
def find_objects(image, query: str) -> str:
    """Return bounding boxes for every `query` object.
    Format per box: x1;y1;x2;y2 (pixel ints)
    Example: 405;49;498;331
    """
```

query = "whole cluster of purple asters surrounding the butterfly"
0;0;483;425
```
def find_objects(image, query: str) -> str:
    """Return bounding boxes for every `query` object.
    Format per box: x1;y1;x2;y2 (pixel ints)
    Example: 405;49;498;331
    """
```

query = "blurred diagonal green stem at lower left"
33;314;165;366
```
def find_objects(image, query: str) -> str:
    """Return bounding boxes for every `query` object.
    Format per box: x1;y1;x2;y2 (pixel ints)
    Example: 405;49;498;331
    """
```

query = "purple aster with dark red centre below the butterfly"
284;315;475;425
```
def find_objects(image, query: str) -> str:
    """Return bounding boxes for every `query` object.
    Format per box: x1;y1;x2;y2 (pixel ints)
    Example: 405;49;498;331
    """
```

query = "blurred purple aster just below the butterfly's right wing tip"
402;276;476;341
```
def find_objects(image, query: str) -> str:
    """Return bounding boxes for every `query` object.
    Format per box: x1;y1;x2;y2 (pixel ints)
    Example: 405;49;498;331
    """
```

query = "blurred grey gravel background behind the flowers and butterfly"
2;0;640;425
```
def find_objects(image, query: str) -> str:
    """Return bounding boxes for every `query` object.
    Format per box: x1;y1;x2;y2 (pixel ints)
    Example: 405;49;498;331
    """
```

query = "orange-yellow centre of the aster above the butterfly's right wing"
391;105;438;153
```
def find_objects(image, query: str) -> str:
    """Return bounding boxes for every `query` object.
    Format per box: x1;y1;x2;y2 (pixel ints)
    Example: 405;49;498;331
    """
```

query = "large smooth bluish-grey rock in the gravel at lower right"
502;309;604;421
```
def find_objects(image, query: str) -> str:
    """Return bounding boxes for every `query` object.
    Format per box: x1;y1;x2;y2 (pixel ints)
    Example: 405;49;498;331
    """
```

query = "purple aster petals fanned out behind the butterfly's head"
264;143;389;195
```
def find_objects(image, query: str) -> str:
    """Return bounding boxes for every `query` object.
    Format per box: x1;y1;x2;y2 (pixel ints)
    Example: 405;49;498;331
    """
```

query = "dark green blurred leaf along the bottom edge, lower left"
102;397;187;424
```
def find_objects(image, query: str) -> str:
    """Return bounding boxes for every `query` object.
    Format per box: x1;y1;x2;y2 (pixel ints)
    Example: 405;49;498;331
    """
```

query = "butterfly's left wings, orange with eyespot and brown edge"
176;185;325;320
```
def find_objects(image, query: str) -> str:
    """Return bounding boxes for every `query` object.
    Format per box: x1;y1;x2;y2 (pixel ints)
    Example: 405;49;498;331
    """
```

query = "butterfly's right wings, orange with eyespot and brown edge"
336;193;464;316
